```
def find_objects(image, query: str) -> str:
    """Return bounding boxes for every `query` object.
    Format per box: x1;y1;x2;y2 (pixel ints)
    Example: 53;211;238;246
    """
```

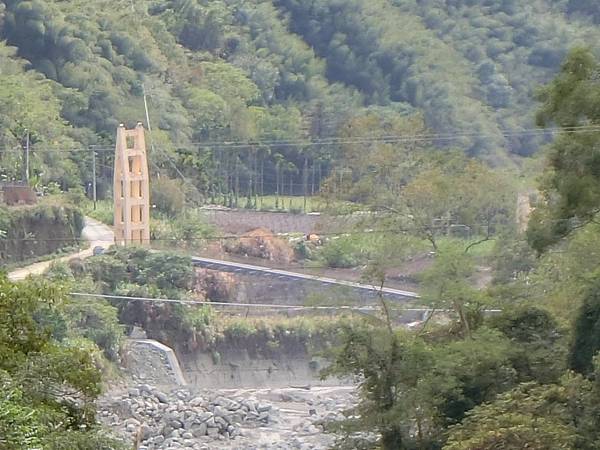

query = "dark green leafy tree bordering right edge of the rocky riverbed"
325;328;432;450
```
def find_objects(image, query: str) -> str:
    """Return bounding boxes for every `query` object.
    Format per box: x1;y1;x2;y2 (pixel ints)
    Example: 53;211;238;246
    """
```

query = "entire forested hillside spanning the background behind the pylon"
0;0;600;198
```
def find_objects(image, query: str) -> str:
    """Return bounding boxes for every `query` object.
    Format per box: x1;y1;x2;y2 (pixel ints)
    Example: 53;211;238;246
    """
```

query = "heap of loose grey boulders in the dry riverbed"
99;384;278;450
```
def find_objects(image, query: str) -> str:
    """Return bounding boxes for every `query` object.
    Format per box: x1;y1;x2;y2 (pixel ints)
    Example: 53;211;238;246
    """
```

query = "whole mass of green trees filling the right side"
318;50;600;450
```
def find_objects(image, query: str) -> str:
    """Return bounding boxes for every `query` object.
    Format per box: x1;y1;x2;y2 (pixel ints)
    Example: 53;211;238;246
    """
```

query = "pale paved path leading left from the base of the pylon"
8;217;114;281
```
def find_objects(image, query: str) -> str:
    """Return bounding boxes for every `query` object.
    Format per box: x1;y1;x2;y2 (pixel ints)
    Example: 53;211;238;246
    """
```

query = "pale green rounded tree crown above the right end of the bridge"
360;154;516;251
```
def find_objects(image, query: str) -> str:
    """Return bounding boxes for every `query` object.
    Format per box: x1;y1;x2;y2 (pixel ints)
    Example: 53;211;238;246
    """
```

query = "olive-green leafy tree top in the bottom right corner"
444;357;600;450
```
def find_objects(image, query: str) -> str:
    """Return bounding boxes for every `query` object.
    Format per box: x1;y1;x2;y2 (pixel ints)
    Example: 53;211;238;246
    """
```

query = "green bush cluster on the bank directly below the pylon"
55;247;207;354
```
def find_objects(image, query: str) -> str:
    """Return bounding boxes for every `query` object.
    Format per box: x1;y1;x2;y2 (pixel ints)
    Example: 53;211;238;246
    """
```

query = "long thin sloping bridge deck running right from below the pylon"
192;256;419;299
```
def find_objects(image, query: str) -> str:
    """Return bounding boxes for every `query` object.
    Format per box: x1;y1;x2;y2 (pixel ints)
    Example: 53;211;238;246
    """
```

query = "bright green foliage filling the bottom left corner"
0;277;121;450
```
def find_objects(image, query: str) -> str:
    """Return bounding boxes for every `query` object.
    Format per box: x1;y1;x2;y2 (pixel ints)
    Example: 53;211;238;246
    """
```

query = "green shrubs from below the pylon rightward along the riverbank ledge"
48;248;357;361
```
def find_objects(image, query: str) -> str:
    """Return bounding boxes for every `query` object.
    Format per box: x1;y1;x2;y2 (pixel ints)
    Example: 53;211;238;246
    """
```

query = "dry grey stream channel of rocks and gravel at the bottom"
98;340;355;450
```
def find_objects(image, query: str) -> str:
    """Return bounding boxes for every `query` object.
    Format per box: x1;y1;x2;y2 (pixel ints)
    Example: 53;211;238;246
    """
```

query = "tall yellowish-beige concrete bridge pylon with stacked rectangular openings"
113;122;150;245
